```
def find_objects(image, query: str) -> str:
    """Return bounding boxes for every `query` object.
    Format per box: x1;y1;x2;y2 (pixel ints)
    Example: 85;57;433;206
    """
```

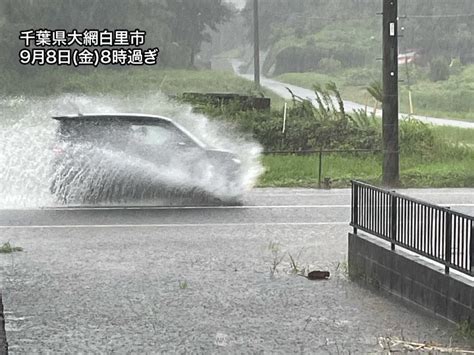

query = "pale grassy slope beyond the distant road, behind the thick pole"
275;65;474;122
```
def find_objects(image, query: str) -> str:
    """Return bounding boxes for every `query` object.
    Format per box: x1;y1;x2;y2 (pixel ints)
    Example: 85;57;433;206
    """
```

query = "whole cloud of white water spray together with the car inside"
0;94;263;208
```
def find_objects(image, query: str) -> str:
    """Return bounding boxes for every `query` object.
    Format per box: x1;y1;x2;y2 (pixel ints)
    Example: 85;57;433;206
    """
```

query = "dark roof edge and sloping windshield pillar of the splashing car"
53;112;207;148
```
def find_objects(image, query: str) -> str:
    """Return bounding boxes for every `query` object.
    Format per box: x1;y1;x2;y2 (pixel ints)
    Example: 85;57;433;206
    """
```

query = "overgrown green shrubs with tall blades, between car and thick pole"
183;83;381;151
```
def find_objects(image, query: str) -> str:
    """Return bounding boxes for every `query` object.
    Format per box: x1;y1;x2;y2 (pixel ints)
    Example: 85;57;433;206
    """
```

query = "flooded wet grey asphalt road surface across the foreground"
0;189;474;354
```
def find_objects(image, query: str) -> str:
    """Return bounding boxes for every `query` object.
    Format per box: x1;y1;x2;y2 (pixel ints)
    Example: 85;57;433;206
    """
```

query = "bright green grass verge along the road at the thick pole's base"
259;152;474;187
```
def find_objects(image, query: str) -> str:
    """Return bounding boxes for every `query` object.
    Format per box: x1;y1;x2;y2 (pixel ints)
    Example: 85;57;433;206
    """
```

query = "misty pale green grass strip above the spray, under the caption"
0;67;284;109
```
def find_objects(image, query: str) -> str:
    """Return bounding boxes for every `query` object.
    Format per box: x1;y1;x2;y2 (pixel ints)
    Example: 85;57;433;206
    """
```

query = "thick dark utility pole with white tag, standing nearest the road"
382;0;400;186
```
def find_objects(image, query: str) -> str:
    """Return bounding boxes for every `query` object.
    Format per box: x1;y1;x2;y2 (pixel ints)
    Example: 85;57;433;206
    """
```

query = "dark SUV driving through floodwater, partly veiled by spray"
50;114;241;203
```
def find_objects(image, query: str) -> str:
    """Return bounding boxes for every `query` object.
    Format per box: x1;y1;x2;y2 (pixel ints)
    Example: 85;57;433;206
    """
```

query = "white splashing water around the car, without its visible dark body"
0;93;263;208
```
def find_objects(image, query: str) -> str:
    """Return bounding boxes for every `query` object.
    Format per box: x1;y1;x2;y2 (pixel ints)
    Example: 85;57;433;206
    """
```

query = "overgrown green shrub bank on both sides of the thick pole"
182;83;462;161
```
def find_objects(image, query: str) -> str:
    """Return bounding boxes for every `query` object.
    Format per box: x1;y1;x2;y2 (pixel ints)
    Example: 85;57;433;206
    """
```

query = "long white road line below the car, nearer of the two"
0;222;349;229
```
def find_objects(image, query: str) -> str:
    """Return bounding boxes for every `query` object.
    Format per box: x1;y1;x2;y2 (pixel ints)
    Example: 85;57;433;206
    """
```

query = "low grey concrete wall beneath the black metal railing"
348;233;474;322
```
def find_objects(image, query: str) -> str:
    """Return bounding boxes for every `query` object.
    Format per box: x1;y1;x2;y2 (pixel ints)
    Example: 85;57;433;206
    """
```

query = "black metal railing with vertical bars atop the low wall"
351;181;474;276
